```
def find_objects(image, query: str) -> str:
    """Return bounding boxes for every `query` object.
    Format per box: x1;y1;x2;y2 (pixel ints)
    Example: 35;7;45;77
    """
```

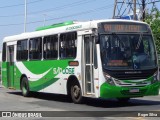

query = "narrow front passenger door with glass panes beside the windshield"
82;35;94;95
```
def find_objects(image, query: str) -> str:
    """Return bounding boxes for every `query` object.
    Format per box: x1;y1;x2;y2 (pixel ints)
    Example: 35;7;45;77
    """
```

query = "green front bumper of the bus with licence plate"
100;82;160;98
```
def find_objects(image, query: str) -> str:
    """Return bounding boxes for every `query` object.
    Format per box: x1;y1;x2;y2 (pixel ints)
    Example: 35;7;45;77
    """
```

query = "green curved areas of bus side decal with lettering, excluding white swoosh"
16;59;74;91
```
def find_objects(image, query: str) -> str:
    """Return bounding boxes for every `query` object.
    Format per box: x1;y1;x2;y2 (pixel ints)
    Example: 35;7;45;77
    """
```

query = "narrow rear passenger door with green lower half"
7;45;14;87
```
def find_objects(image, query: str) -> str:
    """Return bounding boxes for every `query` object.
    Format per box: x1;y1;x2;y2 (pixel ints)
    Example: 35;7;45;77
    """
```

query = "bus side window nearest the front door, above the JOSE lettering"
60;32;77;58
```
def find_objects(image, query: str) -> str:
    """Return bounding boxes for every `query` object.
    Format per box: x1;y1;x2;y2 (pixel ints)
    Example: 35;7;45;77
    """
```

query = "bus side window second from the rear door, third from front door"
29;38;42;60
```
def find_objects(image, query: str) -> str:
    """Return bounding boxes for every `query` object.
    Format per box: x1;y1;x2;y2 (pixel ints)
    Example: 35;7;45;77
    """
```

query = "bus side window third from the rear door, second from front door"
43;35;58;59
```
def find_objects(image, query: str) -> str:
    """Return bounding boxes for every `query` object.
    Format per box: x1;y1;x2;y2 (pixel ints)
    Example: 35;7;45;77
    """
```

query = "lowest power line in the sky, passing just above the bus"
0;4;114;27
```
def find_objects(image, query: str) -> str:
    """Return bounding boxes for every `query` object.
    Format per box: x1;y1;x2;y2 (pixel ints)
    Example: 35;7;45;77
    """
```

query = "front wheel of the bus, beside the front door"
71;82;82;104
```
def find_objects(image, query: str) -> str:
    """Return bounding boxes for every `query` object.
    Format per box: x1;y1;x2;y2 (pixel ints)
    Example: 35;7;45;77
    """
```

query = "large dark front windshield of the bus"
100;33;157;70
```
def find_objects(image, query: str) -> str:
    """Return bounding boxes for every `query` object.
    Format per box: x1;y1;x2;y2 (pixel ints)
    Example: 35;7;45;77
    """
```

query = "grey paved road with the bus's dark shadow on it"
0;86;160;120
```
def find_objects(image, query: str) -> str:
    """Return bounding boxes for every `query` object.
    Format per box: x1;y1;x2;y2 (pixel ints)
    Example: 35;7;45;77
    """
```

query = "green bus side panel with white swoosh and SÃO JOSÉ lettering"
16;59;75;93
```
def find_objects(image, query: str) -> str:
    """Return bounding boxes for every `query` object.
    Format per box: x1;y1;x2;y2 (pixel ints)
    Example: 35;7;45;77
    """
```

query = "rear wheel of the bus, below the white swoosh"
21;77;30;97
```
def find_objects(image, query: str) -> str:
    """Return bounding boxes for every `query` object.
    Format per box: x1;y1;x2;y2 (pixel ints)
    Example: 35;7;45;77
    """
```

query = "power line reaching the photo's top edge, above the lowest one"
0;0;93;17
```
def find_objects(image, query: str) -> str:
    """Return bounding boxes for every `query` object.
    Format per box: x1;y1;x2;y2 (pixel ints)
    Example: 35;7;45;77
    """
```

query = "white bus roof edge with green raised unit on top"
3;19;146;42
